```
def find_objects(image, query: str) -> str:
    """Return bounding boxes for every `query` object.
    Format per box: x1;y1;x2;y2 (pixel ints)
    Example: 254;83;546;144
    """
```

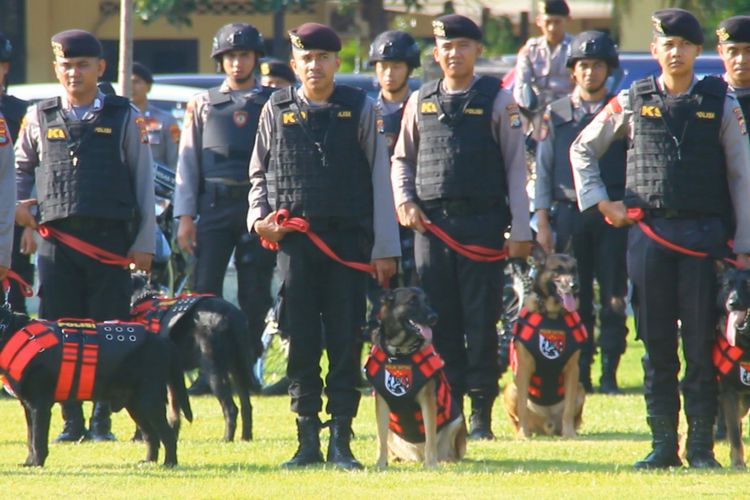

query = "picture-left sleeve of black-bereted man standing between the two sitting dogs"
391;91;419;207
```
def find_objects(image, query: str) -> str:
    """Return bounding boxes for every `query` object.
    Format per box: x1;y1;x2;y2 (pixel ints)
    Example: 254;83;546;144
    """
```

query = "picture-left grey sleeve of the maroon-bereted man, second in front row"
247;103;274;232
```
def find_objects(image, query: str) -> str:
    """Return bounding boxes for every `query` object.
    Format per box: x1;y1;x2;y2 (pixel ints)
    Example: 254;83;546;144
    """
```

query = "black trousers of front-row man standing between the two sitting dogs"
414;209;508;403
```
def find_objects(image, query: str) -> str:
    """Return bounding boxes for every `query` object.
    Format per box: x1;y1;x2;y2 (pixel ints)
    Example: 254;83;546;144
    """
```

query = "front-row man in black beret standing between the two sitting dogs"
392;14;531;439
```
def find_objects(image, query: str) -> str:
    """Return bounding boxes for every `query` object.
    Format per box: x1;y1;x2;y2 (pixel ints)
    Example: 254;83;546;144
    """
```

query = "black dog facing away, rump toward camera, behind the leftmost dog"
130;275;263;441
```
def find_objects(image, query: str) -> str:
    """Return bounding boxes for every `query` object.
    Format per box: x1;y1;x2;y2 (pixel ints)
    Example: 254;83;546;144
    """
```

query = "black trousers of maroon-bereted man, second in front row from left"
278;226;372;417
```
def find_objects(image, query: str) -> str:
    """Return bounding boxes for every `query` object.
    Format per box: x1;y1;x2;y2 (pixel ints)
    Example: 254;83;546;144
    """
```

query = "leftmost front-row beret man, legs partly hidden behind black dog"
16;30;155;441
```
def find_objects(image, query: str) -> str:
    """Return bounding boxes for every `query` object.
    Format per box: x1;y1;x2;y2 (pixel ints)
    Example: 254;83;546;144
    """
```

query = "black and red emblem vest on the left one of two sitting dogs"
365;345;461;443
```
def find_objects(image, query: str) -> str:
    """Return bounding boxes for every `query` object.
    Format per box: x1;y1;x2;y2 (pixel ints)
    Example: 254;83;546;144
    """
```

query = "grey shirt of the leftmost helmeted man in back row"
174;80;262;217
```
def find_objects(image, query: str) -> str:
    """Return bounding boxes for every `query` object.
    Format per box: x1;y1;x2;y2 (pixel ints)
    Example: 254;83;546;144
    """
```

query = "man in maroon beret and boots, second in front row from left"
247;23;400;469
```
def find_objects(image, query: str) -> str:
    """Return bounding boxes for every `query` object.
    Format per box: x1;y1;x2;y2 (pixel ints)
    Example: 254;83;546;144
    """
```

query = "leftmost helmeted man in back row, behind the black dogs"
174;23;275;394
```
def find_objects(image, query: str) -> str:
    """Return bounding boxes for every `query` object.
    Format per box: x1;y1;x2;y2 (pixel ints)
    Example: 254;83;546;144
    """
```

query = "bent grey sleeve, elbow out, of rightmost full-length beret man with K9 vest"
570;90;633;211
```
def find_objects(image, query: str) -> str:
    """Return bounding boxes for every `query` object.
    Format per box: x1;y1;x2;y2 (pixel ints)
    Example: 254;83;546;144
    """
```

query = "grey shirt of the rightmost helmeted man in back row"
534;87;606;210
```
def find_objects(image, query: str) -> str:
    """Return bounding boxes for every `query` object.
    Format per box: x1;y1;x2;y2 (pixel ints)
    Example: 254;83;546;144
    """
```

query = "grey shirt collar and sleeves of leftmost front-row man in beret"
15;92;156;254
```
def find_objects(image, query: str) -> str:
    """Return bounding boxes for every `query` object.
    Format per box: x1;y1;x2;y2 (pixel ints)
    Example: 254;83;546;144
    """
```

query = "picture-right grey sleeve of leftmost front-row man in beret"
122;108;156;254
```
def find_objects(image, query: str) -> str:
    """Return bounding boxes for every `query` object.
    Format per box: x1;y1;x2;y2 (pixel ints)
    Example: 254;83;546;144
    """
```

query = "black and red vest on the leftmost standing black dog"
0;318;150;401
